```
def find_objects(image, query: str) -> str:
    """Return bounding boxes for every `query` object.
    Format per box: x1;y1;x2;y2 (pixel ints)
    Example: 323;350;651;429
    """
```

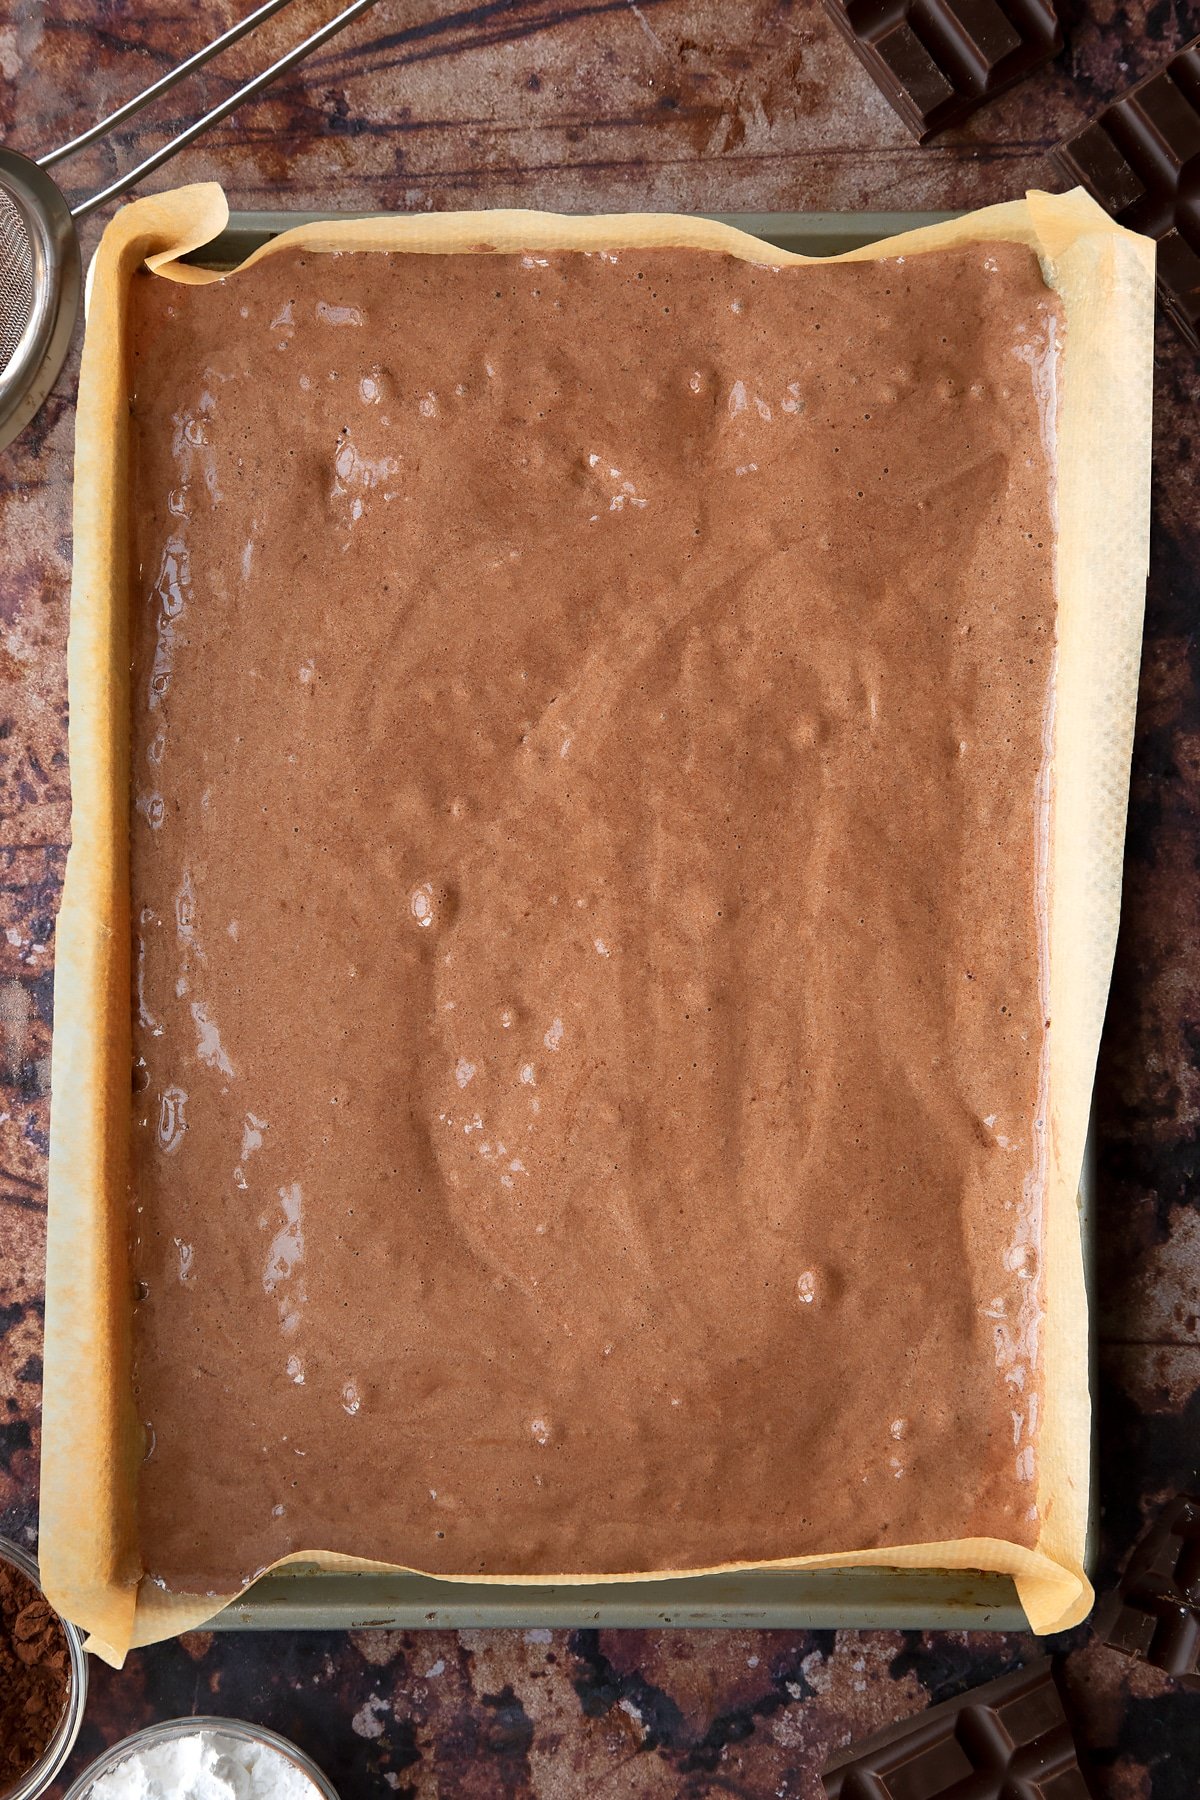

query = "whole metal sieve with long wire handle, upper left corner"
0;0;374;450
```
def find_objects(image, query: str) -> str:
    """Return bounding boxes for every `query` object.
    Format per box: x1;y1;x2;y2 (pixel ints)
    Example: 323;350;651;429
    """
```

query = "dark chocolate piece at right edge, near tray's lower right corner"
1096;1494;1200;1688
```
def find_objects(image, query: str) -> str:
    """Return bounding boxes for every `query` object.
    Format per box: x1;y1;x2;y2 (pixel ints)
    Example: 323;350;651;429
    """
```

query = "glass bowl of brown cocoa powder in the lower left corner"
0;1537;88;1800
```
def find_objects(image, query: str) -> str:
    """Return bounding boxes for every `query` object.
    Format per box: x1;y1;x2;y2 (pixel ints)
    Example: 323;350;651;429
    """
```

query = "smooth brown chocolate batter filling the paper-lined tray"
131;245;1060;1589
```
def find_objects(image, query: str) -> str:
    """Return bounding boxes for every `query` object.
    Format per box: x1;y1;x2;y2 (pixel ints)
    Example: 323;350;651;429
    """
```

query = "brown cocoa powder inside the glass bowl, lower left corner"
0;1557;70;1796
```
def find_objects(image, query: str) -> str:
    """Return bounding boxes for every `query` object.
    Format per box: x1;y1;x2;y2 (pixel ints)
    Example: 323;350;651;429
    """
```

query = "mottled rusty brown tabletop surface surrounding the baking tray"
0;0;1200;1800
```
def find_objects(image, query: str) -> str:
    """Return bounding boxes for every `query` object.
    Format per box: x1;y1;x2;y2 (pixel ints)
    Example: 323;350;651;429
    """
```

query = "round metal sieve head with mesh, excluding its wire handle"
0;144;83;448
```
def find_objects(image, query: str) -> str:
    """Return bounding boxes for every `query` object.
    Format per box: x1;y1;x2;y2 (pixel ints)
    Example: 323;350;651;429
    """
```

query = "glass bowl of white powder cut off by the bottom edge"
67;1719;338;1800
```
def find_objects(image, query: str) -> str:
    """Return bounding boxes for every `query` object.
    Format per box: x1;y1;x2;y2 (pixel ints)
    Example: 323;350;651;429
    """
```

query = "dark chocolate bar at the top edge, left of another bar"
826;0;1063;142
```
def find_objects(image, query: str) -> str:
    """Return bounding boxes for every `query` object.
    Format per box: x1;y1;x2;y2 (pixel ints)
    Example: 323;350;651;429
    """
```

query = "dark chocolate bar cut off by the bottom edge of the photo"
820;1656;1088;1800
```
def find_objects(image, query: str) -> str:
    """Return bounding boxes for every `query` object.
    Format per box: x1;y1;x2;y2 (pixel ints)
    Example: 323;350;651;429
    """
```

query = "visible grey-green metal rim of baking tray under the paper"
176;212;1096;1631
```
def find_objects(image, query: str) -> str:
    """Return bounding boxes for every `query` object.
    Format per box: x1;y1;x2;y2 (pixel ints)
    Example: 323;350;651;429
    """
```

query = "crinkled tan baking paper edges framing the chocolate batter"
41;185;1153;1663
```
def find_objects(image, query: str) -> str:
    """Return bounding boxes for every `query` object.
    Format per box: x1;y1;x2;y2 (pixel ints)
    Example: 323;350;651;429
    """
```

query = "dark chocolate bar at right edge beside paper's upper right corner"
1054;38;1200;349
